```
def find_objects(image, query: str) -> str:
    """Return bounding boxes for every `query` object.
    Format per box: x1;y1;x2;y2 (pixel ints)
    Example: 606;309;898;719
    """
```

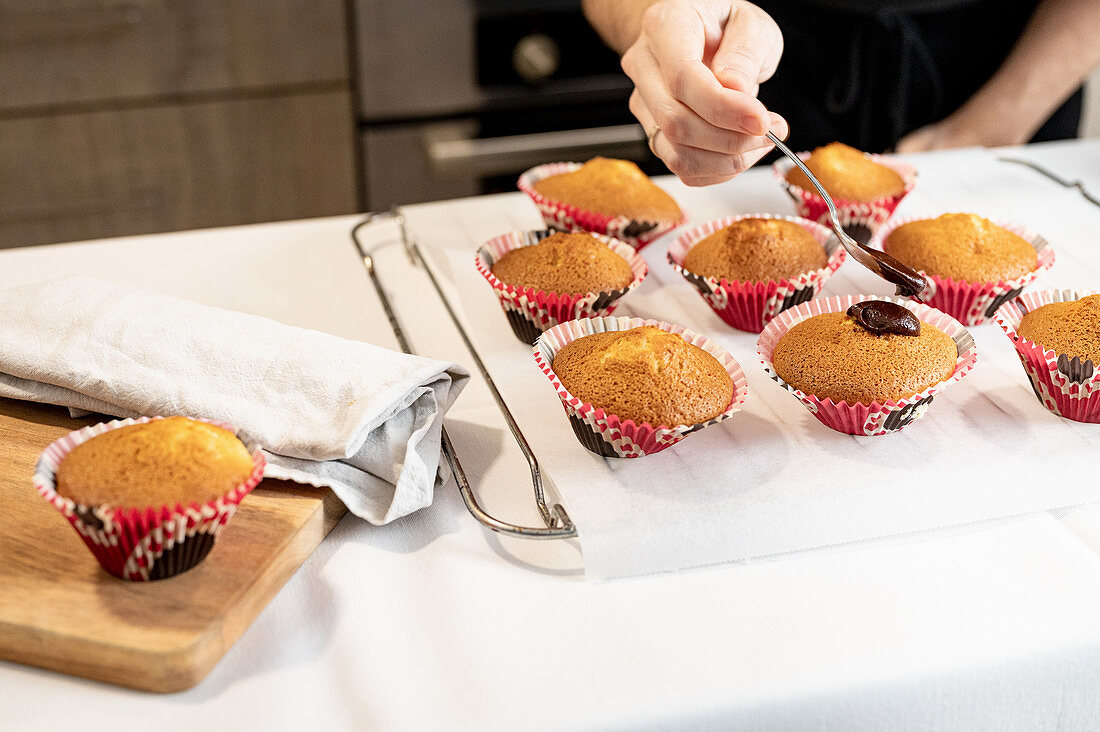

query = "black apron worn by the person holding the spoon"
755;0;1082;150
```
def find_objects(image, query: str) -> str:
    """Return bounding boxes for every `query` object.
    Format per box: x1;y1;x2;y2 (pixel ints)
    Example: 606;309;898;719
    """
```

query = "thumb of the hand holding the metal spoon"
711;2;783;94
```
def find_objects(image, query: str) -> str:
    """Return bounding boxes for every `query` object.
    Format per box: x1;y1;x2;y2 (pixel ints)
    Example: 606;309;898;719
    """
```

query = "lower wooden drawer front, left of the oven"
0;88;358;247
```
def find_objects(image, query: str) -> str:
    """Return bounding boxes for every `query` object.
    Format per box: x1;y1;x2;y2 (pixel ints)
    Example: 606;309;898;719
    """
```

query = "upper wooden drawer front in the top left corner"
0;0;349;111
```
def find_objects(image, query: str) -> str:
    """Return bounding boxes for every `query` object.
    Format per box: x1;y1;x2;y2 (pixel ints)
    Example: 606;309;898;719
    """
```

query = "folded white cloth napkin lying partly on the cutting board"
0;276;469;524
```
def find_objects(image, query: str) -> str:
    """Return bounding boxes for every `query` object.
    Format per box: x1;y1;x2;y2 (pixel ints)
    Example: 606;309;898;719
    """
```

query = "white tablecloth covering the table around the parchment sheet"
0;141;1100;730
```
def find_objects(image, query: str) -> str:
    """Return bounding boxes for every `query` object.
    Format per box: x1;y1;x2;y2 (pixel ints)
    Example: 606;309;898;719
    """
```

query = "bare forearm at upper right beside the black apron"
953;0;1100;145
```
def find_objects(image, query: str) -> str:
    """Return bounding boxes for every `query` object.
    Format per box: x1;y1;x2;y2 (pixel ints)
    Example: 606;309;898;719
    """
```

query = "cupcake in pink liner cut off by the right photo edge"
993;289;1100;423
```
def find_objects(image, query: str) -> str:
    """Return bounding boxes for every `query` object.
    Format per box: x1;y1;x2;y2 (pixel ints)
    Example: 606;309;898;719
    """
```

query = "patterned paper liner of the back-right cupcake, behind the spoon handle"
771;152;916;244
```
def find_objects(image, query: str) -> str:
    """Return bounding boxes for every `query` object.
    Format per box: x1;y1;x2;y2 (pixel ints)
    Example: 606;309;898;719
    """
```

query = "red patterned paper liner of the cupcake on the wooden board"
33;417;265;581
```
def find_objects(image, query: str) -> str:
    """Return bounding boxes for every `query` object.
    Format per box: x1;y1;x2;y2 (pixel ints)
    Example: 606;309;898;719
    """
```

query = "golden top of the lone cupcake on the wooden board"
57;417;253;507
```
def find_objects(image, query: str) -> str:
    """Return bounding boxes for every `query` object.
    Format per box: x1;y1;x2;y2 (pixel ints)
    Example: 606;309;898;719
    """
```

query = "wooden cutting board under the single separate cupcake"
0;398;345;691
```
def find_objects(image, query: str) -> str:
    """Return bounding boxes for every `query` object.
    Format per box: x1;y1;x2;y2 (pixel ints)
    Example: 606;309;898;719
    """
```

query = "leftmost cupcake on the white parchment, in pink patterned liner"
475;229;649;346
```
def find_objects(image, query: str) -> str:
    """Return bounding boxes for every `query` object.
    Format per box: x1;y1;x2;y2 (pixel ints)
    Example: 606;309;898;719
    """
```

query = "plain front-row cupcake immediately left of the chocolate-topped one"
535;317;748;458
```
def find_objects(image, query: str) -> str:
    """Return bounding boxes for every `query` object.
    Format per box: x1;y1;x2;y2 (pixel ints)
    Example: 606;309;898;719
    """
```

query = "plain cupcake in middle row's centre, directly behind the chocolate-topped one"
668;214;847;332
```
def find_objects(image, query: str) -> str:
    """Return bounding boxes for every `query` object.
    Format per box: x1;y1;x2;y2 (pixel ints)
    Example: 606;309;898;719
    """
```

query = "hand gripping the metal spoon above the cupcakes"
623;0;789;186
